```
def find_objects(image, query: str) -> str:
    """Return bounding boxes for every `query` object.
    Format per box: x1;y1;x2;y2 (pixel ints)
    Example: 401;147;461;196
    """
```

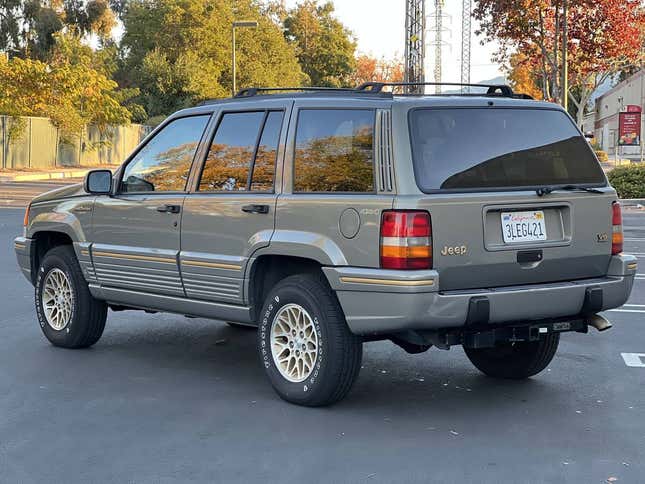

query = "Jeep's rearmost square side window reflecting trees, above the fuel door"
293;109;375;192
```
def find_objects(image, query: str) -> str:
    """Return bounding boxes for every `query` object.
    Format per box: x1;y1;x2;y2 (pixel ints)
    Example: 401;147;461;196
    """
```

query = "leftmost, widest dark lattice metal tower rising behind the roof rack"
404;0;426;94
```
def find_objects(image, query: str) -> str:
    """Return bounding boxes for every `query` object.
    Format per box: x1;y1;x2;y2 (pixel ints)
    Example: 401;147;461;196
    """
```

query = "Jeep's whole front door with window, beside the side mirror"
91;114;210;296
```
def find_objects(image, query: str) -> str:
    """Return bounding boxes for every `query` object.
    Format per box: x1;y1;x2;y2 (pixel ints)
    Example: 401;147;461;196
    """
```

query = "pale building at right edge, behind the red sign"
582;70;645;161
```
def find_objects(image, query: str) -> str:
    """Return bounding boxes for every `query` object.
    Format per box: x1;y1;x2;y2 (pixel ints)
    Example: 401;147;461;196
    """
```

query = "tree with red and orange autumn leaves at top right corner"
474;0;645;124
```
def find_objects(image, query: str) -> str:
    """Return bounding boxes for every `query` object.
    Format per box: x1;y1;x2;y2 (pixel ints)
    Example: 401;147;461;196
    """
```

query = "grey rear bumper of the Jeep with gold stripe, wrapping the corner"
323;254;636;335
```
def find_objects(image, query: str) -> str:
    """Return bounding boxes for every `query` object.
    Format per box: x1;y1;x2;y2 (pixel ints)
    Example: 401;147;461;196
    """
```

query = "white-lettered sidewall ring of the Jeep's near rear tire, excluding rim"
258;284;329;403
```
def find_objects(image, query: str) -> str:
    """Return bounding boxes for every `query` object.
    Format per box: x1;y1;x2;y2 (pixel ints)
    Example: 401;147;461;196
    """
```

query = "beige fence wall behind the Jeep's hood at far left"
0;116;151;169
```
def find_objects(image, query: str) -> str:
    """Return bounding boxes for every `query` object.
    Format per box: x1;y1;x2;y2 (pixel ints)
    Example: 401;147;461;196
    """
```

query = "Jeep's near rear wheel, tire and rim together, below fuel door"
258;274;363;407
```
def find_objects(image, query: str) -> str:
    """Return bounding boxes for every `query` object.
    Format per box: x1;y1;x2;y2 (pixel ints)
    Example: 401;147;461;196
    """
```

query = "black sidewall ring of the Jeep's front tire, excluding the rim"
35;253;79;345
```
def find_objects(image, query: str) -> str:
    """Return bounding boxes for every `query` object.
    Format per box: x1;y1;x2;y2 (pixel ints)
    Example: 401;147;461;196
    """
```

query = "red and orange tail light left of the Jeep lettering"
381;210;432;269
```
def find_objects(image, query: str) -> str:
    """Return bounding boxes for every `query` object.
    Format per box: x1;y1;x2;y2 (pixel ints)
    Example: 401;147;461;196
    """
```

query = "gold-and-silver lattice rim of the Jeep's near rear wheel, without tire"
271;304;318;383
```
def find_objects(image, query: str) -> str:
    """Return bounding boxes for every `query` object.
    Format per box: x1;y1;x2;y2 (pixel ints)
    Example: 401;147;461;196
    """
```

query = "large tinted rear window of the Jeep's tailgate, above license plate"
410;108;606;192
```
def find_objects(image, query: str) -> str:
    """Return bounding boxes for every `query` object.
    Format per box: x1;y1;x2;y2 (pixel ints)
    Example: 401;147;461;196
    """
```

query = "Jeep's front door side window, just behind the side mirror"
119;115;210;193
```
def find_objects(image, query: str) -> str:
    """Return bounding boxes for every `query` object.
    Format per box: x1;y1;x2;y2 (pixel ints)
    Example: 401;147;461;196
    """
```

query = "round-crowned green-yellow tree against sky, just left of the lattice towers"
284;0;356;87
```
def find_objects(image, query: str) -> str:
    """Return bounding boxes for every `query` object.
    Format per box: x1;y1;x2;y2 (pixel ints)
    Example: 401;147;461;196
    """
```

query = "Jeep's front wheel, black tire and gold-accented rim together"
35;245;107;348
